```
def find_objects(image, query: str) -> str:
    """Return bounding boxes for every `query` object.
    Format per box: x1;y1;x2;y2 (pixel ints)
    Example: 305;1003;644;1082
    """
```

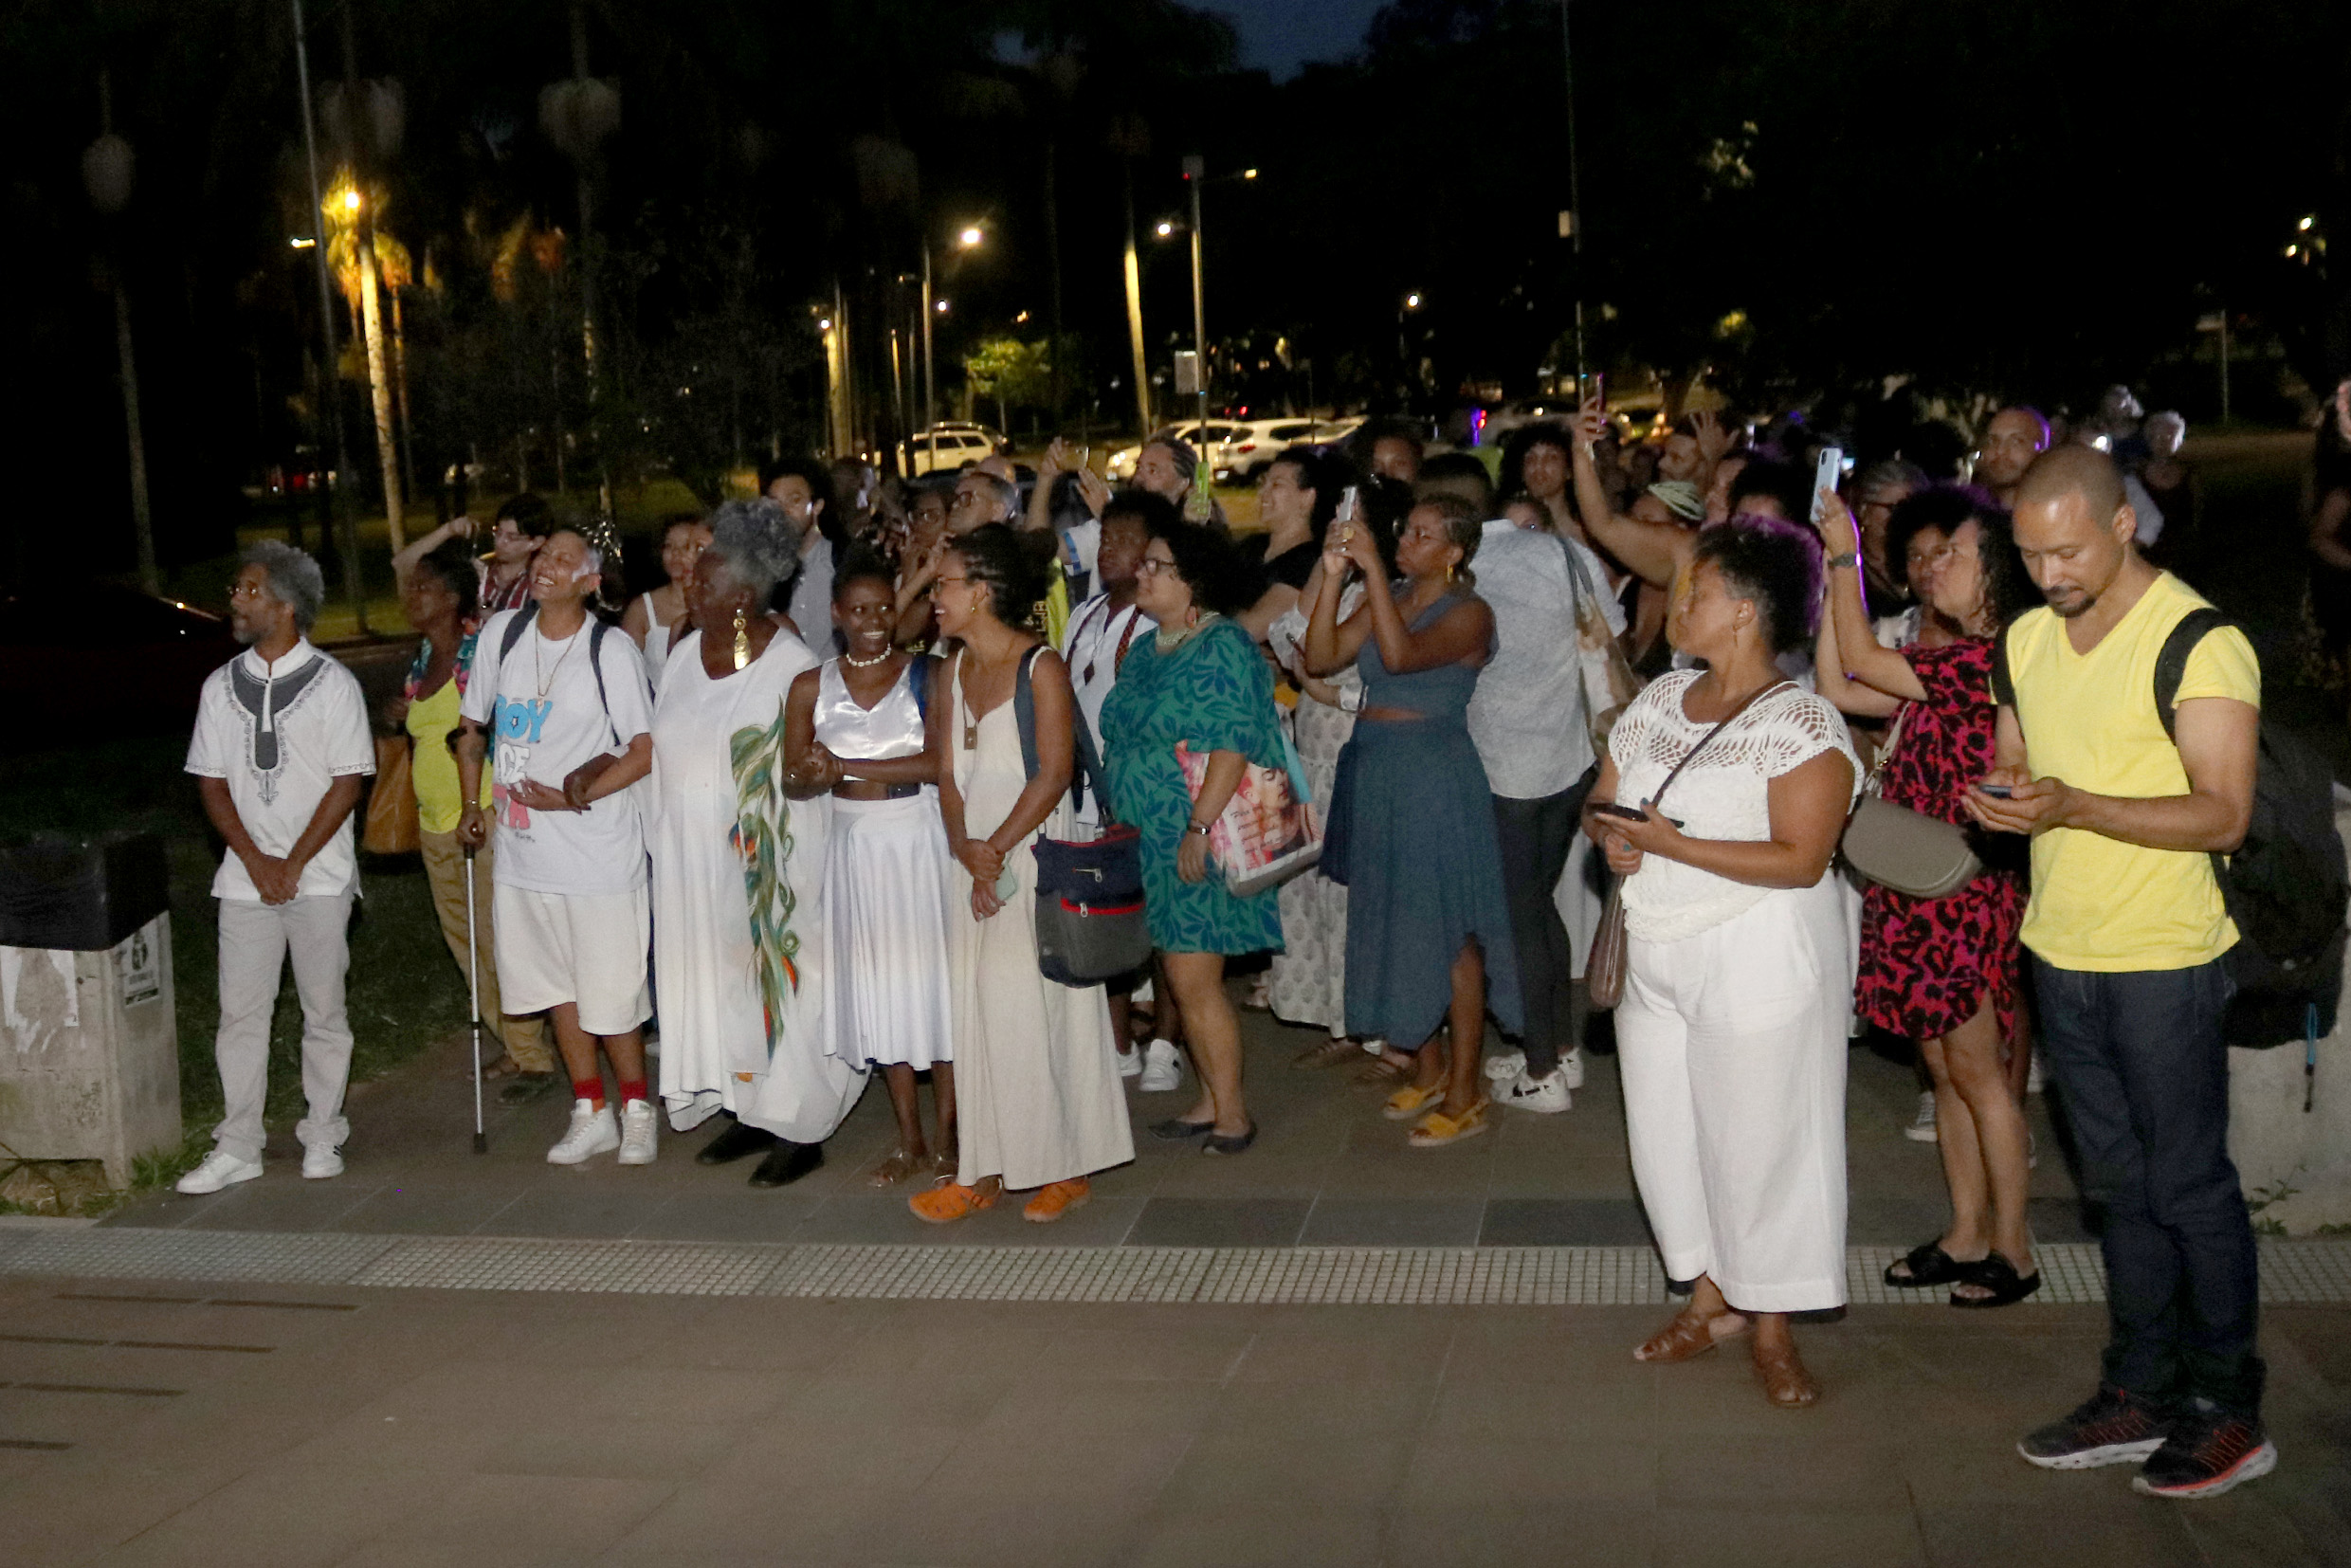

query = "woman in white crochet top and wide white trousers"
1585;518;1860;1406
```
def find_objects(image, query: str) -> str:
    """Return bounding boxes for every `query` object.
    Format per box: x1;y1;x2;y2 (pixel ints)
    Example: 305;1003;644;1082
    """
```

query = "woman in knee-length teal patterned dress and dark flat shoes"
1103;524;1284;1155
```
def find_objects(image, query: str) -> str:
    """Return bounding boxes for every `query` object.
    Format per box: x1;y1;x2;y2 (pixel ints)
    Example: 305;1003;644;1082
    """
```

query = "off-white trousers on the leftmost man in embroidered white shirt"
211;893;355;1159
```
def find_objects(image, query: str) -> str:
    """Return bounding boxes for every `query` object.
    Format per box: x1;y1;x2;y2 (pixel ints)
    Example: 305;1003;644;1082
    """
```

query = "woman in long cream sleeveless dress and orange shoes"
910;524;1136;1225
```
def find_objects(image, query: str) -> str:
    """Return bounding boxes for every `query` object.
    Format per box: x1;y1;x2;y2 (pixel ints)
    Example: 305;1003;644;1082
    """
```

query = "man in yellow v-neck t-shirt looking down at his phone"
1968;447;2278;1498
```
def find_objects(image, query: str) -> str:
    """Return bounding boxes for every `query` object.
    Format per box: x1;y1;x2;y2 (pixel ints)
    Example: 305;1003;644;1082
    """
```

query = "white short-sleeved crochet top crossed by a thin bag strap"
1608;670;1862;942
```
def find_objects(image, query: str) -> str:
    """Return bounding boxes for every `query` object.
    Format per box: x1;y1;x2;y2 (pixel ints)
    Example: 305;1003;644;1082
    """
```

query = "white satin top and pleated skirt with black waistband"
813;658;955;1072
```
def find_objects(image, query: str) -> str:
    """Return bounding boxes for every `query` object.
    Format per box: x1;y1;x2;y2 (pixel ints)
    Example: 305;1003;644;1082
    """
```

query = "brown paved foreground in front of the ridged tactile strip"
0;1277;2351;1568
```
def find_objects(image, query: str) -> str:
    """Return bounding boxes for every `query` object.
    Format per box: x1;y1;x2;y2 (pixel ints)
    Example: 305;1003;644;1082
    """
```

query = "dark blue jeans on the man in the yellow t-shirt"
2033;959;2262;1415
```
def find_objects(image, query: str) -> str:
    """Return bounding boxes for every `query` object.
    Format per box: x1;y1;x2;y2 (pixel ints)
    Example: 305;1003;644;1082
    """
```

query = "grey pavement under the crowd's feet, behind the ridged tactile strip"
108;1011;2090;1249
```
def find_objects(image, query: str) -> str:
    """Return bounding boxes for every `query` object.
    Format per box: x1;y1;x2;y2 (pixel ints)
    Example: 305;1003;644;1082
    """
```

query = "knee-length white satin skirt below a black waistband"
825;790;955;1072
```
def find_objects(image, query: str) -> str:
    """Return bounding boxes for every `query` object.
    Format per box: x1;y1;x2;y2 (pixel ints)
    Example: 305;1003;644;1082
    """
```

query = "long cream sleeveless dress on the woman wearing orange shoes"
947;658;1136;1190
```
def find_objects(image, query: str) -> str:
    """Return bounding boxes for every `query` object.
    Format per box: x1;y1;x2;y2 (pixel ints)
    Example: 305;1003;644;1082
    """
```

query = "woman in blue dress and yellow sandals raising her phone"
1303;496;1522;1147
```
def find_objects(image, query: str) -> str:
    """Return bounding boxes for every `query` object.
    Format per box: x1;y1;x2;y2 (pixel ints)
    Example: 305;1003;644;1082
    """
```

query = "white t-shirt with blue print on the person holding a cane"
461;609;653;893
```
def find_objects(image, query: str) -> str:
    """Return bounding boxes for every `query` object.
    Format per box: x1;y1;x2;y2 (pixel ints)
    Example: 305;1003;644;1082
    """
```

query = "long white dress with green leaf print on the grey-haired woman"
647;630;866;1142
